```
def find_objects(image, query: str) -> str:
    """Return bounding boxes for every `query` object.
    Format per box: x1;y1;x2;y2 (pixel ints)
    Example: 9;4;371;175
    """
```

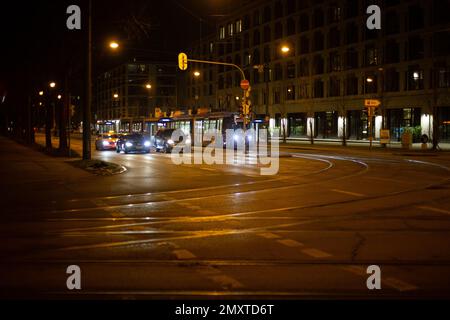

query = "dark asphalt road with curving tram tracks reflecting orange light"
0;134;450;299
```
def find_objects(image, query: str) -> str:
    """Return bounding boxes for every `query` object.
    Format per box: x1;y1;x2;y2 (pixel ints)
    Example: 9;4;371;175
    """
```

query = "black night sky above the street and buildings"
0;0;249;100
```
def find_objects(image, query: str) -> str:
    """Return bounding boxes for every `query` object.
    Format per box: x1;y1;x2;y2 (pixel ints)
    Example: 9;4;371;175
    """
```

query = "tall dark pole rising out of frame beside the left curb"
83;0;92;160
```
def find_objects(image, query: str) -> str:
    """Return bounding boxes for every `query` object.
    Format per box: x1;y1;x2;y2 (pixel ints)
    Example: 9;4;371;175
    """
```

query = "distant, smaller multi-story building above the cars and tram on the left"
94;62;178;131
